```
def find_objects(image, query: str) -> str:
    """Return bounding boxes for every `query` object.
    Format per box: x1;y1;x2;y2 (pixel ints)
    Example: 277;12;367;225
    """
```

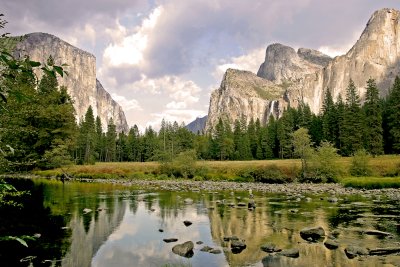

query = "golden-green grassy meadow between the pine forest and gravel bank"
33;155;400;189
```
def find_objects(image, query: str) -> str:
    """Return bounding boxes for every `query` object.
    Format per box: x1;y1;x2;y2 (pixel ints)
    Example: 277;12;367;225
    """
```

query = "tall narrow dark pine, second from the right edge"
363;79;383;155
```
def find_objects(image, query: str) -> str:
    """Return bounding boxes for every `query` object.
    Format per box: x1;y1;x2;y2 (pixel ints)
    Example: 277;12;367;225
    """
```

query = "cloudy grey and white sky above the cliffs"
0;0;400;130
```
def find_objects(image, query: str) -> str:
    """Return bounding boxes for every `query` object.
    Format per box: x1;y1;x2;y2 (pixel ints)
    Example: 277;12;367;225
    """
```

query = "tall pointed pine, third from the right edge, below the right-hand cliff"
340;80;364;156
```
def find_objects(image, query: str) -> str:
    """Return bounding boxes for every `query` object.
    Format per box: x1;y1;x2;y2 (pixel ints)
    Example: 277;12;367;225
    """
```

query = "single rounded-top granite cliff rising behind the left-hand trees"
14;33;128;132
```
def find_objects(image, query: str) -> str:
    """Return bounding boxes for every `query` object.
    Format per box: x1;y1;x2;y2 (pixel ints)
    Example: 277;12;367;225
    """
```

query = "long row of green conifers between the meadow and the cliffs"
79;77;400;163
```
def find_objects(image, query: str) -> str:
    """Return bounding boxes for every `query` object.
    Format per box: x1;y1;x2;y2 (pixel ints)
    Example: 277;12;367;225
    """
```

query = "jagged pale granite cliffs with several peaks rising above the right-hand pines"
206;8;400;132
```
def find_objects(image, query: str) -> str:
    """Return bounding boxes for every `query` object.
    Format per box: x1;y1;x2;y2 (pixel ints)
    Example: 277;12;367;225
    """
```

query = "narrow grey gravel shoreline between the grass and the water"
78;179;400;200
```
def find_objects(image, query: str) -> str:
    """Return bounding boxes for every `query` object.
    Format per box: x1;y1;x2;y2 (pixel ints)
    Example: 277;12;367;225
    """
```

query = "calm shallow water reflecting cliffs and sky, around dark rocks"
0;180;400;267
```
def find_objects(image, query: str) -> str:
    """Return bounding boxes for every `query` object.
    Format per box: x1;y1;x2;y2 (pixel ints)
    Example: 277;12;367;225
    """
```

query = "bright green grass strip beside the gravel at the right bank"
340;177;400;189
